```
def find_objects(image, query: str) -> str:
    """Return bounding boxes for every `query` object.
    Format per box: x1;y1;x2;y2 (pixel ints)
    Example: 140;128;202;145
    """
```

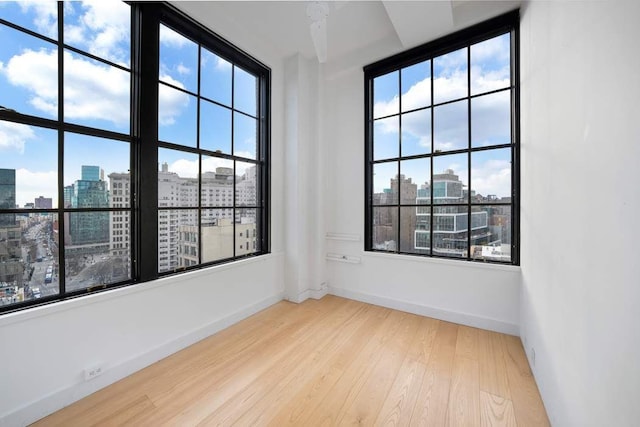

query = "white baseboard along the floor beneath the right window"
329;286;520;336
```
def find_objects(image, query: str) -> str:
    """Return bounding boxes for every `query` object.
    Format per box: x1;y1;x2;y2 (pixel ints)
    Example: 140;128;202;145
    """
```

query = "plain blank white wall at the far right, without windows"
521;1;640;426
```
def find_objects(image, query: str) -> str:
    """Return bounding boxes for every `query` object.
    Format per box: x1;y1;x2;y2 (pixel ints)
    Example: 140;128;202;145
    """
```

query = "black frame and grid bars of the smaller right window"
363;10;520;265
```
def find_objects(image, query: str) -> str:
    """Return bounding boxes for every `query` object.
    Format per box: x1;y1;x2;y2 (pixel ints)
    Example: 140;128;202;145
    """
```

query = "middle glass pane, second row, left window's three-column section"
200;100;231;154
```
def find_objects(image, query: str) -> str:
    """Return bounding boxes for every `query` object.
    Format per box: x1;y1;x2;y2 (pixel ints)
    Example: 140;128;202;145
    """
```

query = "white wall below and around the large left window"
0;2;285;426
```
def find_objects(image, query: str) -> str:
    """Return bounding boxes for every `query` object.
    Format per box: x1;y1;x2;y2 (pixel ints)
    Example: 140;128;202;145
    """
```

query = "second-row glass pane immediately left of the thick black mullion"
64;51;131;133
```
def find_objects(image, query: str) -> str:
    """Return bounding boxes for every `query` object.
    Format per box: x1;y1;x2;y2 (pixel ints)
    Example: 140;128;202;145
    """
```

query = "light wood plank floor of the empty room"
35;296;549;426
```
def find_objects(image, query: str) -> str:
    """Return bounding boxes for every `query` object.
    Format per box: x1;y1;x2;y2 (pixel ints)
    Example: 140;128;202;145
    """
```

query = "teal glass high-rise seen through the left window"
64;166;109;252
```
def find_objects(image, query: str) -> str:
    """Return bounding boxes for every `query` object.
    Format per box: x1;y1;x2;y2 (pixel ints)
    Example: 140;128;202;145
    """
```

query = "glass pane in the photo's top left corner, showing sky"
0;1;58;39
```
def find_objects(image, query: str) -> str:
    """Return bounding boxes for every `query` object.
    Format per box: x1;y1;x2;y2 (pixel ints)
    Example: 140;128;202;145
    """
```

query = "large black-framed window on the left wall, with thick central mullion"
0;0;270;311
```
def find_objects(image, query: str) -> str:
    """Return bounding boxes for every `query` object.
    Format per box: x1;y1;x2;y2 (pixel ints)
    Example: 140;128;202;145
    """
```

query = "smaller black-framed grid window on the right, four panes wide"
364;11;519;264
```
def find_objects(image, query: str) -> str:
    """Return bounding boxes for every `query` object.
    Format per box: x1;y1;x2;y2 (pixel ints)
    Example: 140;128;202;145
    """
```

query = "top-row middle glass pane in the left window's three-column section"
200;48;231;107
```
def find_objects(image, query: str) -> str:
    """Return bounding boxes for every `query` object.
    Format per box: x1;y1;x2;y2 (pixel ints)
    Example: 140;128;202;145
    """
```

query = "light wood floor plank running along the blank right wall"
502;335;550;427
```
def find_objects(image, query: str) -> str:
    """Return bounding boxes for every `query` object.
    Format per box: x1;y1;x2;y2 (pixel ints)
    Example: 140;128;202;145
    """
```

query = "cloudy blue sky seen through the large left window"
0;0;257;206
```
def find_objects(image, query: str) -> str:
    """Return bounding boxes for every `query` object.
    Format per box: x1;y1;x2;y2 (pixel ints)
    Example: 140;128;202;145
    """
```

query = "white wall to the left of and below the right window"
321;43;520;334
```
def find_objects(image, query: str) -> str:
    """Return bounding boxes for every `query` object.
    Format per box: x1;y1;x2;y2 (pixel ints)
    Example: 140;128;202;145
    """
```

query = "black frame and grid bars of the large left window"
0;1;271;315
